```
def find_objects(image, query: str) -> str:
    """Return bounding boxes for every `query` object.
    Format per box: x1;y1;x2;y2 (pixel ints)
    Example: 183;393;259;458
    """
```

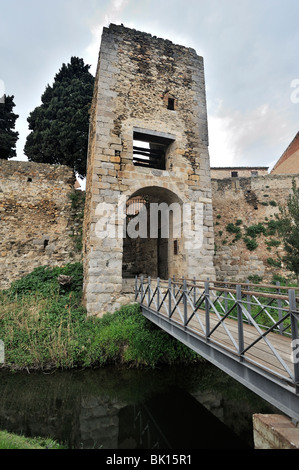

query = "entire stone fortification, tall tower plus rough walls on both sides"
0;25;299;300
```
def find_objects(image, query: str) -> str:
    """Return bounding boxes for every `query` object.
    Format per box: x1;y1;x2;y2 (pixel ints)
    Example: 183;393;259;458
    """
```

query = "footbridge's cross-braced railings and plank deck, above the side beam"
135;277;299;386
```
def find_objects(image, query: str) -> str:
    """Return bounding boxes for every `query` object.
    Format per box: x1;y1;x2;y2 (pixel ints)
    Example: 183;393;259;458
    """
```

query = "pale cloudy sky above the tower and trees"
0;0;299;173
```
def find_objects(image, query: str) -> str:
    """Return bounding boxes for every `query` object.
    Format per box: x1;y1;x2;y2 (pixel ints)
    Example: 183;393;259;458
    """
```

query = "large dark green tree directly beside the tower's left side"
24;57;94;177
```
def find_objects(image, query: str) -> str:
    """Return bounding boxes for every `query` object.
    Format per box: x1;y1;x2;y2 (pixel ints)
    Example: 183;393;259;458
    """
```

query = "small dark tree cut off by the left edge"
0;96;19;160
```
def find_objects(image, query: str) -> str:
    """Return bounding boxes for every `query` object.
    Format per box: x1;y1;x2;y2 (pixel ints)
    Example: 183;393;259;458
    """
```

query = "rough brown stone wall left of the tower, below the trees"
0;160;83;289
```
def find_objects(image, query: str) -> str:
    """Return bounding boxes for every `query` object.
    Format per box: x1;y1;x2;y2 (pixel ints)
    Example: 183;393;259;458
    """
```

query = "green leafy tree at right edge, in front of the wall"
277;179;299;285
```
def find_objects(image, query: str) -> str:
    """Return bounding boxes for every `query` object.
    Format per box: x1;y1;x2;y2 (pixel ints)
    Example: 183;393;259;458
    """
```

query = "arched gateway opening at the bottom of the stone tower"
122;186;185;279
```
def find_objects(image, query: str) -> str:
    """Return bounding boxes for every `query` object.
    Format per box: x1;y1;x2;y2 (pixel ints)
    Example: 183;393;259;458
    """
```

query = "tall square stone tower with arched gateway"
84;24;214;315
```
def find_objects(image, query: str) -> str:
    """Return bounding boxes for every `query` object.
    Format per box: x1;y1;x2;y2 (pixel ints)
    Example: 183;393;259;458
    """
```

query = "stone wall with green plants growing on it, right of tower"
212;175;299;281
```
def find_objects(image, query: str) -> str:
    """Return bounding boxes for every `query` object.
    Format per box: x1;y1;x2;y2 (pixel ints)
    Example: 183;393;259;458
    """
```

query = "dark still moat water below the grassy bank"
0;364;273;449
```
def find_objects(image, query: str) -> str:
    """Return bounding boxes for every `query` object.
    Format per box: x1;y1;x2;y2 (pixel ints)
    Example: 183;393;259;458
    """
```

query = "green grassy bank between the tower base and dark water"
0;263;199;370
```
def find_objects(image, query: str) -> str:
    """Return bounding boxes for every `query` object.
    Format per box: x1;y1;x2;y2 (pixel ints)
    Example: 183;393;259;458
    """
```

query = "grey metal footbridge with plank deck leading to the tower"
135;277;299;421
